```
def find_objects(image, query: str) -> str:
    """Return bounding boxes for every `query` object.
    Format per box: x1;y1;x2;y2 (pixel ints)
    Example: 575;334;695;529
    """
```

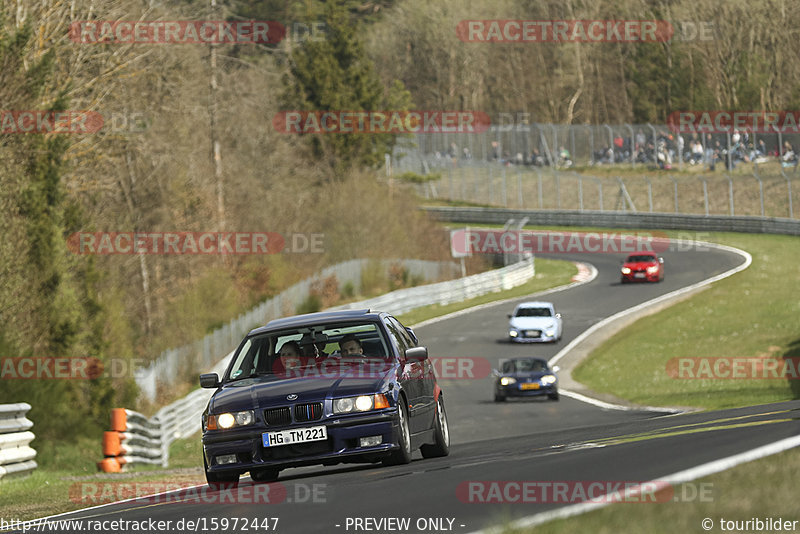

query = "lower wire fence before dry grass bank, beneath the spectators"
404;162;800;219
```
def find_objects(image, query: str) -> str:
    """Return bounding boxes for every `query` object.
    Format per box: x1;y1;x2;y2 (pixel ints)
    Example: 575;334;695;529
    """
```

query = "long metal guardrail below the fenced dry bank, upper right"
423;206;800;235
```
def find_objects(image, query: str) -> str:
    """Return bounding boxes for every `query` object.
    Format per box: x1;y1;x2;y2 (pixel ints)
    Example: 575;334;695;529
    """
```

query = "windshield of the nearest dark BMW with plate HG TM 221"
226;323;391;381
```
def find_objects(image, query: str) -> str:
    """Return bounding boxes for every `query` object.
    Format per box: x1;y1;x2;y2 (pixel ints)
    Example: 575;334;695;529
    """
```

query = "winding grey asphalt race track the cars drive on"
23;243;800;534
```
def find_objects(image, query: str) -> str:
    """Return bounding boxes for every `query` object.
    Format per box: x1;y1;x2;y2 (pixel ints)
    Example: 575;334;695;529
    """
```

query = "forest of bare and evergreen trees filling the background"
0;0;800;448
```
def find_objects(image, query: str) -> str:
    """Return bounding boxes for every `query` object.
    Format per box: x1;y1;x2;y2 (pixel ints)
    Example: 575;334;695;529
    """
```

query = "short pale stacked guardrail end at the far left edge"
0;402;37;479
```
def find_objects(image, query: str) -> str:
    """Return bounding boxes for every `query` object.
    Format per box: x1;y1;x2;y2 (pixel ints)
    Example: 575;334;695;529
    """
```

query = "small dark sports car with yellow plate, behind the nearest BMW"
494;358;558;402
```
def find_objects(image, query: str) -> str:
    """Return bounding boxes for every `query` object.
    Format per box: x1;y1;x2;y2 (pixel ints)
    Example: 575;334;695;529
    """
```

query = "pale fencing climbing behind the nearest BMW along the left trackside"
135;259;460;401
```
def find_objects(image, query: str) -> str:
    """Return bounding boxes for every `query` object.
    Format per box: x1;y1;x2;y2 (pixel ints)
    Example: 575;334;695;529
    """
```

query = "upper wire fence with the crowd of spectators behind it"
392;122;800;174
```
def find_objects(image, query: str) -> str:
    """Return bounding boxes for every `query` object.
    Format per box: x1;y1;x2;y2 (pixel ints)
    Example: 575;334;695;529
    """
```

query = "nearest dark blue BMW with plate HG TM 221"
200;310;450;486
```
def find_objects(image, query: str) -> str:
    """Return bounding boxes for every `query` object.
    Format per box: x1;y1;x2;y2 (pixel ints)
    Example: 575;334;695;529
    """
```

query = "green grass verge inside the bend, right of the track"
573;233;800;410
